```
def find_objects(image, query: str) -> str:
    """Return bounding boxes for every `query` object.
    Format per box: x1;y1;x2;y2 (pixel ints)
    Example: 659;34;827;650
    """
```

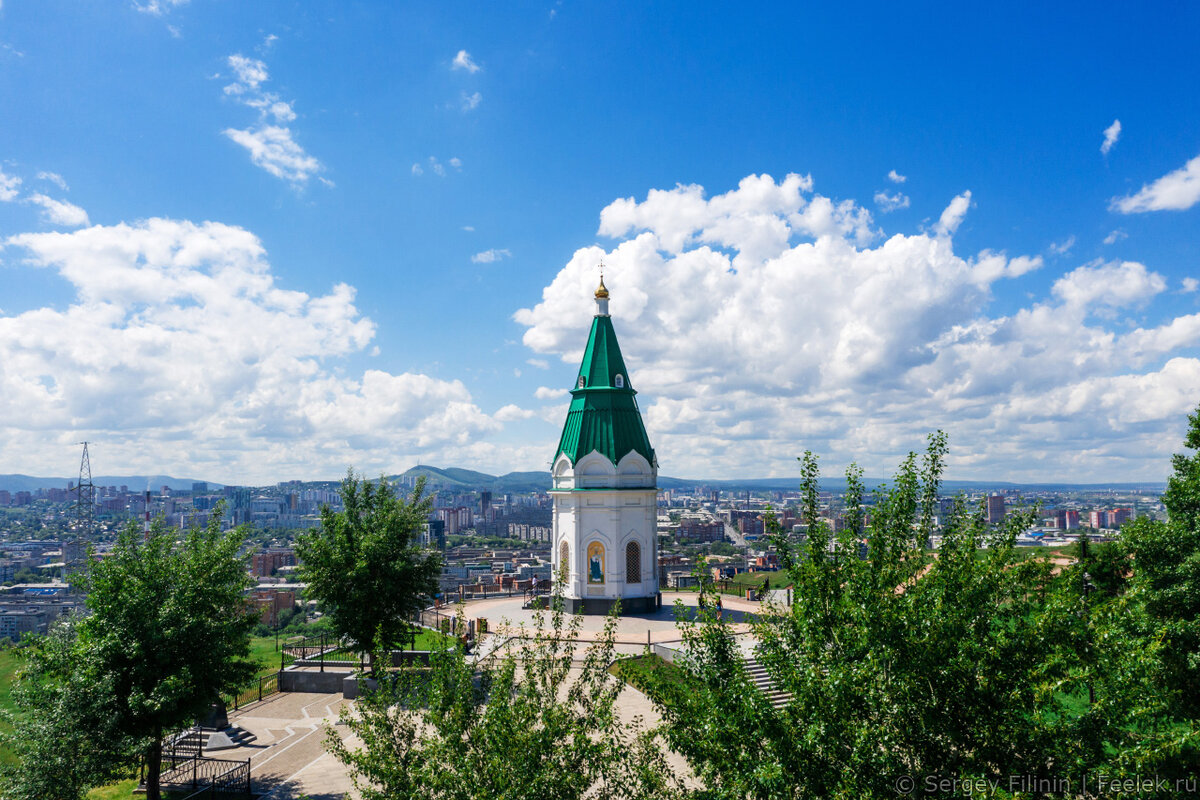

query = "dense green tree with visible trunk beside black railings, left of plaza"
87;515;257;800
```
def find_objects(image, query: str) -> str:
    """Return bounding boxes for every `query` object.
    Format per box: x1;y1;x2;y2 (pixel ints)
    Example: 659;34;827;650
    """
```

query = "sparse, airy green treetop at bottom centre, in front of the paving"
326;596;677;800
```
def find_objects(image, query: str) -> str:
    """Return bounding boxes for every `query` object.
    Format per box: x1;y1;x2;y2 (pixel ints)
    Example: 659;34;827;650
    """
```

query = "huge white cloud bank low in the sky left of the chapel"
0;218;501;482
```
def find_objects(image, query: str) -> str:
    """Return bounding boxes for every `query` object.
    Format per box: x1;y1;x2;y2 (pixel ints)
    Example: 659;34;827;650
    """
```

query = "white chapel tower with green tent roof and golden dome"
550;277;661;614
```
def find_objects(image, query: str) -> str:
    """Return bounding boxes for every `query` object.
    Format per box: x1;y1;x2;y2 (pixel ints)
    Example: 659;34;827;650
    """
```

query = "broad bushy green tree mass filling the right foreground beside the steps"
652;433;1178;798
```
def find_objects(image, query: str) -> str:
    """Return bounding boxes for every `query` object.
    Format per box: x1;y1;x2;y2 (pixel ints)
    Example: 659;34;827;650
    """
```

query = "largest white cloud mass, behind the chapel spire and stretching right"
515;176;1200;480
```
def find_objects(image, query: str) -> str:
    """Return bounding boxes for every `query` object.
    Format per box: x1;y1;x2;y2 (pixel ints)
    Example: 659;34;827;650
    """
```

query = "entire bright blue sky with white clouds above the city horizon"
0;0;1200;482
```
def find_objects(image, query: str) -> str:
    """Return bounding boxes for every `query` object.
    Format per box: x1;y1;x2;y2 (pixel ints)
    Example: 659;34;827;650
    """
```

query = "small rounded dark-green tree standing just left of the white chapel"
296;471;442;669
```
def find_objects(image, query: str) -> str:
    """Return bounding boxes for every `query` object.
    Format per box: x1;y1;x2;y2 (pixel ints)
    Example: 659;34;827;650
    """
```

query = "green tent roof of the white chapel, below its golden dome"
554;314;654;464
